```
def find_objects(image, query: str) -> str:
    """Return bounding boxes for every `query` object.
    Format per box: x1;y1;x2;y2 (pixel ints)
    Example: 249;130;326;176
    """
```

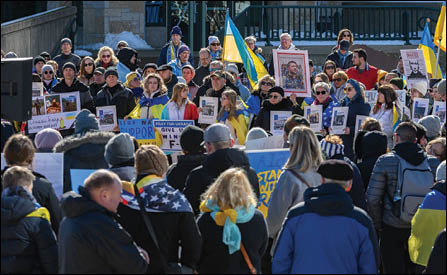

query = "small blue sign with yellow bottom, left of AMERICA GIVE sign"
118;119;156;146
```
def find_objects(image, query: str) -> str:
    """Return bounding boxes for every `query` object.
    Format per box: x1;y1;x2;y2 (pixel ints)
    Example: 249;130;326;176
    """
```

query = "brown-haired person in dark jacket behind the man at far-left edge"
1;134;61;233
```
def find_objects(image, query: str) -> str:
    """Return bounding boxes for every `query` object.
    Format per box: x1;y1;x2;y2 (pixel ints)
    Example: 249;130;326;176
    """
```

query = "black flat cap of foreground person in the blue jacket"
317;159;354;181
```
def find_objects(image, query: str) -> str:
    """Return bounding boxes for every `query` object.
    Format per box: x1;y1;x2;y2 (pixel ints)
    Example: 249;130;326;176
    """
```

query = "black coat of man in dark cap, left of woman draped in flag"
96;83;136;119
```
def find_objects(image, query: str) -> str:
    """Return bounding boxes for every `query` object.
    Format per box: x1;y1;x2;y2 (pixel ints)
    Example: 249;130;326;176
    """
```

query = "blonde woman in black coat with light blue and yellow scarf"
197;168;268;274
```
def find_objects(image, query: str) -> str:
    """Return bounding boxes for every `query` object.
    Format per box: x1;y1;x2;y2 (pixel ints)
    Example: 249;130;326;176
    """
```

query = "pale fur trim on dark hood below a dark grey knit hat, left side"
53;130;115;153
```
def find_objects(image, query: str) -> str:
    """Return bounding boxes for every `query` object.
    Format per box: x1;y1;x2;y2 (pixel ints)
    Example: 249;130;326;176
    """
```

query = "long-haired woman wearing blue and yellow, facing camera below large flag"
217;89;248;145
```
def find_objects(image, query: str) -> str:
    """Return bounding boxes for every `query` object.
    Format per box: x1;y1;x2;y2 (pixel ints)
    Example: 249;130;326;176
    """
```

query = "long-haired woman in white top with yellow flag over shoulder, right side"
370;85;401;150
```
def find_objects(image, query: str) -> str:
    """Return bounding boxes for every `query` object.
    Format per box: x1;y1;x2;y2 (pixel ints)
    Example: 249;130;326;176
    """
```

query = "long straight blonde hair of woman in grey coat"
283;126;323;172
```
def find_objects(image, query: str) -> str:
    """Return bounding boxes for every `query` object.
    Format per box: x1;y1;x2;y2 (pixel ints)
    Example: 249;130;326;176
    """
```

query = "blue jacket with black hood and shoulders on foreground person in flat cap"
272;183;379;274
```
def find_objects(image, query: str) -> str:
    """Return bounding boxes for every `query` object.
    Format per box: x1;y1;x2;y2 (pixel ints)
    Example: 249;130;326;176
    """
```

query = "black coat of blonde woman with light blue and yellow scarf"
197;210;268;274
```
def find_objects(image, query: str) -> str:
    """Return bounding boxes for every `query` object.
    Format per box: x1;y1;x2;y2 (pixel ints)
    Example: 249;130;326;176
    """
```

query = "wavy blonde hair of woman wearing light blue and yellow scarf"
202;168;257;209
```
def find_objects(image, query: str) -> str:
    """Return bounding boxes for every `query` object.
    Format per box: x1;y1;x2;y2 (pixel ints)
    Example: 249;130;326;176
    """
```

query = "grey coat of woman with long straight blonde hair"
267;166;321;242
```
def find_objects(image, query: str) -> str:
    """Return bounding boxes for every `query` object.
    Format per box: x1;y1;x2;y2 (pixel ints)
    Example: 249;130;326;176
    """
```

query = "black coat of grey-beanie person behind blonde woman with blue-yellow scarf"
183;148;259;215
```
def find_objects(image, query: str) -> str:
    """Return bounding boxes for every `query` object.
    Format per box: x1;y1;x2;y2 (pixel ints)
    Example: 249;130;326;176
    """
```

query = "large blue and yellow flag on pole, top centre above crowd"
222;12;268;87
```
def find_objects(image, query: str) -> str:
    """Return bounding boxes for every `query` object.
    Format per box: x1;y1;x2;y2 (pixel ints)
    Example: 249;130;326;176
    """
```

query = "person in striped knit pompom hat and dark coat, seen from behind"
320;134;367;211
